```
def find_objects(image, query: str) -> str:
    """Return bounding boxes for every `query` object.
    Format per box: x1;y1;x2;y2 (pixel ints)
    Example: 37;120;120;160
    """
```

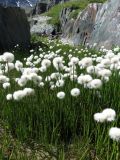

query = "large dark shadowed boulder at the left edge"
0;6;30;50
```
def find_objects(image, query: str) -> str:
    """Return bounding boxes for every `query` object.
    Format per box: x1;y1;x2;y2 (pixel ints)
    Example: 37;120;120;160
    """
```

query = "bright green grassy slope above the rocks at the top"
44;0;106;26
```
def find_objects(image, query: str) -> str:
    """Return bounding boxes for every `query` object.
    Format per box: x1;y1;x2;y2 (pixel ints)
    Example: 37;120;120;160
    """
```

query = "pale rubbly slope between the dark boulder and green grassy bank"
29;0;68;35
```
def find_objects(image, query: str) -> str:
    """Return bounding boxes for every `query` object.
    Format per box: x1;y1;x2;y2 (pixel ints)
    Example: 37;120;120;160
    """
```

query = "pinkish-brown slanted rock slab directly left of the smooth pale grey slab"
72;3;101;45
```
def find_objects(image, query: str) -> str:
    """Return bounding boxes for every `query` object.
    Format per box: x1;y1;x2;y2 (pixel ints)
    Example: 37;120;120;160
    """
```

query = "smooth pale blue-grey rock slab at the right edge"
89;0;120;49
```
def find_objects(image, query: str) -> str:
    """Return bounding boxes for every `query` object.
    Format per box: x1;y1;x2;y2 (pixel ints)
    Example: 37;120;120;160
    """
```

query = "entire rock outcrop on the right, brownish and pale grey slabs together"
60;0;120;49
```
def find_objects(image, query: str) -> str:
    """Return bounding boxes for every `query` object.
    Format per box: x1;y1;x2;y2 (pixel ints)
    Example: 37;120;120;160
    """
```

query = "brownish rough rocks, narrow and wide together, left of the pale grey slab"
60;3;101;45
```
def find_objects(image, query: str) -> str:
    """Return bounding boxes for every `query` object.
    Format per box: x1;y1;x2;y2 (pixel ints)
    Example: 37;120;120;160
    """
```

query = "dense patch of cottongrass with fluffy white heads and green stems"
0;37;120;160
